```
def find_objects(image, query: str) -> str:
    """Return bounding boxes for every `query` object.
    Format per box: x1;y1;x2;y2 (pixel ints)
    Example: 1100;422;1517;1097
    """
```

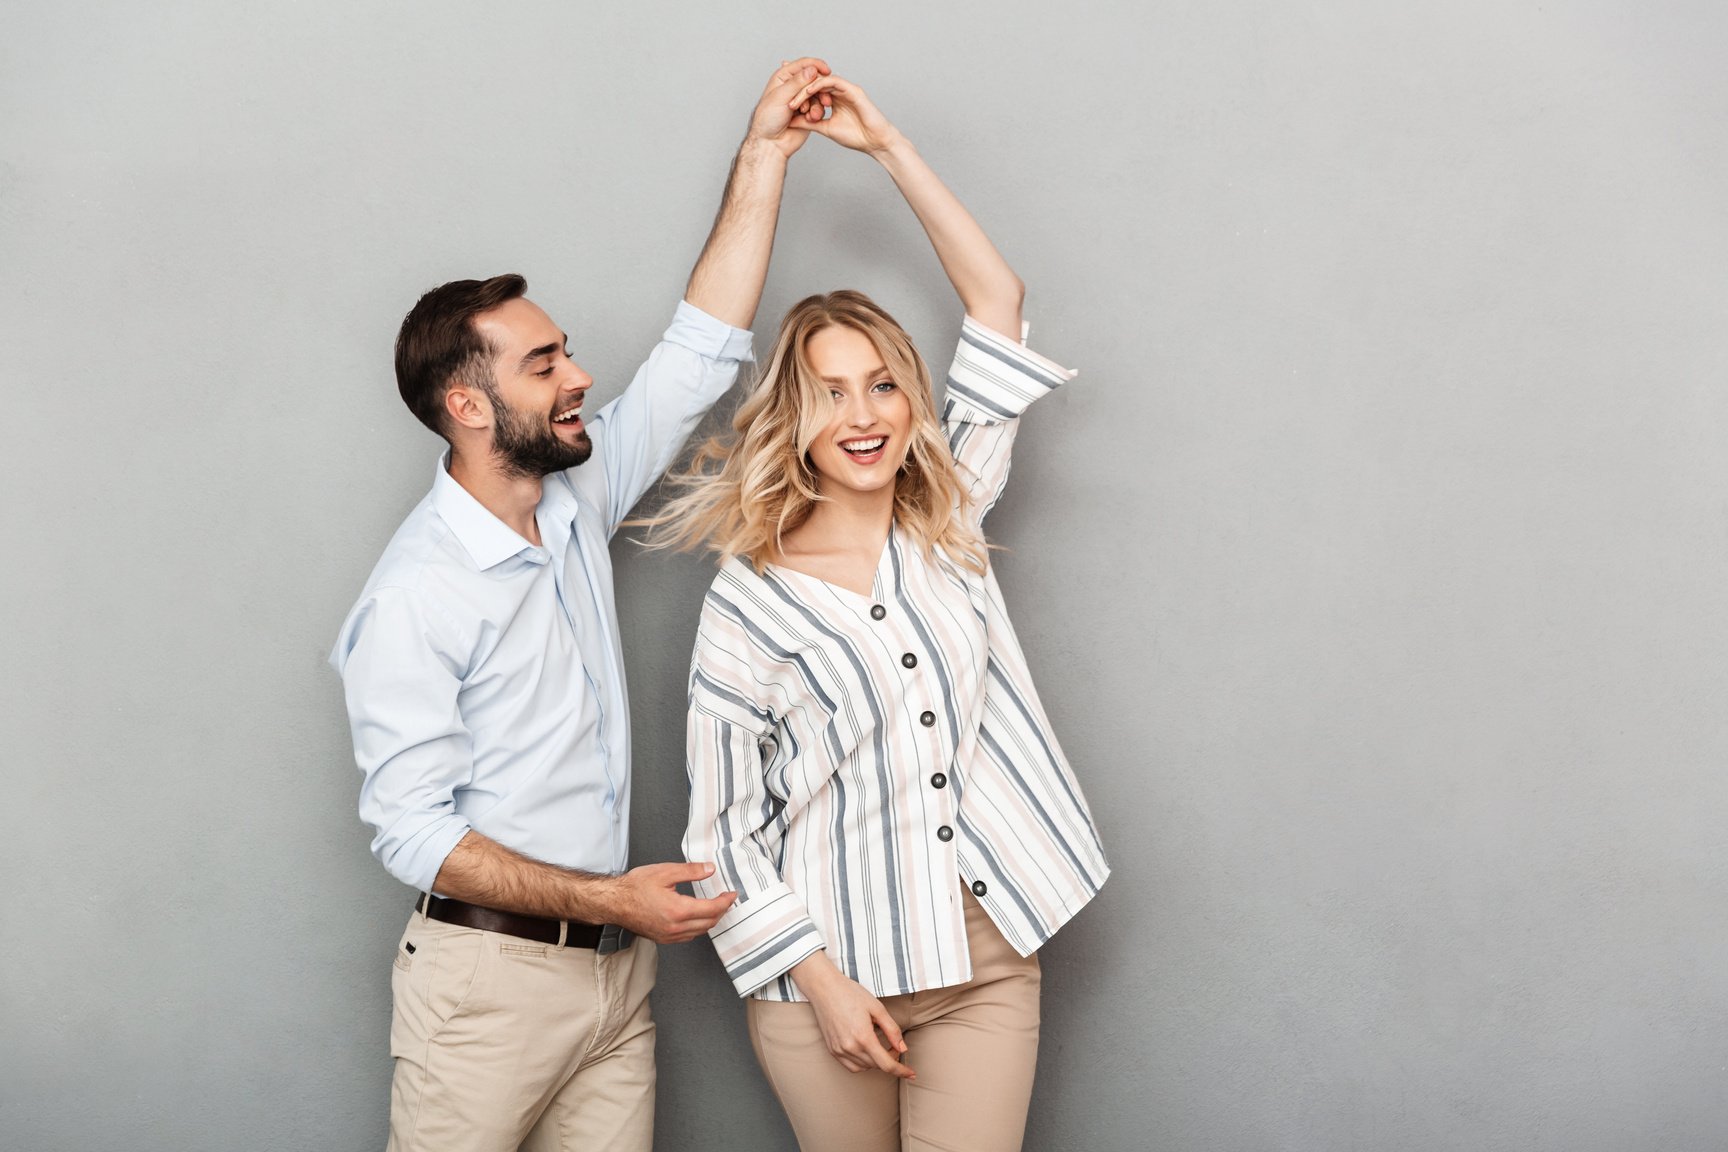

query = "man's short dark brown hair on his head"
396;273;529;440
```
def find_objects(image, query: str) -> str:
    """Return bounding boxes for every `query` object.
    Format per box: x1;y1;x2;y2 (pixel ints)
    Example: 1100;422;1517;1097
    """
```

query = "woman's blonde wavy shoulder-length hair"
634;290;987;573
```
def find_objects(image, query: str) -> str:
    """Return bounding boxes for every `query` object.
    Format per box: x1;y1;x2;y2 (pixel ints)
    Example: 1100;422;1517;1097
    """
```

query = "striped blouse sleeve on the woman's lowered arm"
684;617;823;997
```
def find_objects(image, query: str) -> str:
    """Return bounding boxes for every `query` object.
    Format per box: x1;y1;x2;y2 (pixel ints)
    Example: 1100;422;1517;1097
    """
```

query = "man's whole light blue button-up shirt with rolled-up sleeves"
330;302;752;891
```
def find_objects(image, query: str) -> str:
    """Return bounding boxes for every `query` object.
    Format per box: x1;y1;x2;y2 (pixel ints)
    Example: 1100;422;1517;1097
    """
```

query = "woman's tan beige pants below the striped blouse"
745;891;1042;1152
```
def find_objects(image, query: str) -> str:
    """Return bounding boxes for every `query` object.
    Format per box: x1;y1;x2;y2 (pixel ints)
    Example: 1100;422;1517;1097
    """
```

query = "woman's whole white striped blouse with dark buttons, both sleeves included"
684;318;1109;1000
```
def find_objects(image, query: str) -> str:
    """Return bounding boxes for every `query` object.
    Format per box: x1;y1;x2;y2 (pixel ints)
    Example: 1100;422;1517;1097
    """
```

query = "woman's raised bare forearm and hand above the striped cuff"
793;76;1026;344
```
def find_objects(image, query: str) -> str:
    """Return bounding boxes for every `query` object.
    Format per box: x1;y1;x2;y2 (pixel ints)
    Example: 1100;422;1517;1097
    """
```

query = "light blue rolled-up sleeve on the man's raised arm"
584;301;753;535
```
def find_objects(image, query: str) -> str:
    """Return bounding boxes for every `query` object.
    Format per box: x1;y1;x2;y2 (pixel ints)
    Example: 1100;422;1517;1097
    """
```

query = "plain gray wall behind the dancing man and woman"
0;0;1728;1152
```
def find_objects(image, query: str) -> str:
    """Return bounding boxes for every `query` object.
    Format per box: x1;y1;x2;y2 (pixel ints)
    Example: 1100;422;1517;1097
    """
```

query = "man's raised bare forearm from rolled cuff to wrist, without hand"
684;135;786;328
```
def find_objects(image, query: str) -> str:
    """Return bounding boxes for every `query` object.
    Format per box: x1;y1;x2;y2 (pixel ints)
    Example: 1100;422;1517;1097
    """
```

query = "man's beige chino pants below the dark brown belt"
389;912;658;1152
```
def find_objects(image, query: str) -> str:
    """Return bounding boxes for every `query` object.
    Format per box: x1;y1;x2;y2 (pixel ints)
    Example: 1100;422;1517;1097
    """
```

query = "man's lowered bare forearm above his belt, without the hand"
434;829;619;924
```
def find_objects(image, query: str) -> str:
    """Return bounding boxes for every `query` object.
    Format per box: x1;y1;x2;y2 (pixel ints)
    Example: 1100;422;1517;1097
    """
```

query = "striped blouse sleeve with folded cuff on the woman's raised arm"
942;316;1077;527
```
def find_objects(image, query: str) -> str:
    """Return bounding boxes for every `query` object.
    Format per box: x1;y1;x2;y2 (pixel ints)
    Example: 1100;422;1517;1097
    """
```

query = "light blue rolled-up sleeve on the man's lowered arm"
330;587;473;891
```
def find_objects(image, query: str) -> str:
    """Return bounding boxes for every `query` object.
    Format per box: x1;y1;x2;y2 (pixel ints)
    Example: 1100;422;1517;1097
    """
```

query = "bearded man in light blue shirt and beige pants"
330;57;829;1152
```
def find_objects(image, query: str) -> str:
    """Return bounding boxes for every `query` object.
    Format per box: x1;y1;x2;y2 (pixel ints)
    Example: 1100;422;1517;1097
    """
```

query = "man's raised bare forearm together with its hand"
684;55;829;328
